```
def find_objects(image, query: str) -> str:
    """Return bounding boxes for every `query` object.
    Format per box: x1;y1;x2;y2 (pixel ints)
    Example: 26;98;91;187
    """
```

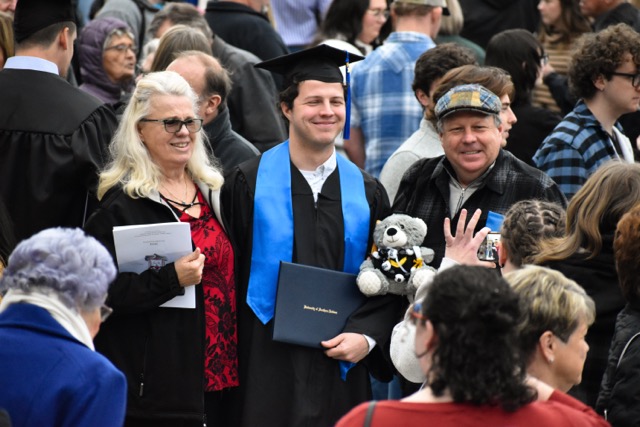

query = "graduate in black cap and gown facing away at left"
0;0;117;240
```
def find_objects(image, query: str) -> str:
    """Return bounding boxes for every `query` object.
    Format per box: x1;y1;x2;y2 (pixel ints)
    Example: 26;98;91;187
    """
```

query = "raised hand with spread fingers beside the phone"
444;209;496;268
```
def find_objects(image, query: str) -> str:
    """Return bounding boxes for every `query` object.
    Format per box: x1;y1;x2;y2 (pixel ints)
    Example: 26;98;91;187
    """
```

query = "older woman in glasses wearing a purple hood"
78;17;137;105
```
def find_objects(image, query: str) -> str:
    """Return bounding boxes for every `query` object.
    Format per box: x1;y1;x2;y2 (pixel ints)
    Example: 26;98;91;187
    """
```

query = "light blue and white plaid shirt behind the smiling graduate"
351;32;435;177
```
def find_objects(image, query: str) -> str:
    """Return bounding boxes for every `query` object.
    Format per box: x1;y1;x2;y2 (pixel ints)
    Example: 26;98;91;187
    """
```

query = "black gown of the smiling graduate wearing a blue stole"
221;159;402;427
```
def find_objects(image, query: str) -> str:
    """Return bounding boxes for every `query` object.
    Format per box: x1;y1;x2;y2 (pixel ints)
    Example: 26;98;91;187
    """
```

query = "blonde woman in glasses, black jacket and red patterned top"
85;71;238;426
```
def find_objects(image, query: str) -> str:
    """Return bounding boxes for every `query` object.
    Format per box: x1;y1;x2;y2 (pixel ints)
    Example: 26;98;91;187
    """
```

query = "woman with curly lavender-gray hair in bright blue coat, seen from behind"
0;228;126;427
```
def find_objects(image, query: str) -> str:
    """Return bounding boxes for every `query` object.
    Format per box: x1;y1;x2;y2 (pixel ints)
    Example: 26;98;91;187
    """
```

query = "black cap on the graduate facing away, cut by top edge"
13;0;76;43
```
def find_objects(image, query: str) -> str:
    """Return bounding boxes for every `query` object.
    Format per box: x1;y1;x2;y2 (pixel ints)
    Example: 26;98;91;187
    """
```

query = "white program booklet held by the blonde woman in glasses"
113;222;196;308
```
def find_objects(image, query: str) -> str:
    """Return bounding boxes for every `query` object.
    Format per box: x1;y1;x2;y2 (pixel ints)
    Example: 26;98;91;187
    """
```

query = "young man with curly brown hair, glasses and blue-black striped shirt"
533;24;640;199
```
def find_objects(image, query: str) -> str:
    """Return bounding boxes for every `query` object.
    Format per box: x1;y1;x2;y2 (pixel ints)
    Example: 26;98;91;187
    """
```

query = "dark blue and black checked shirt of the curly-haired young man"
533;101;626;199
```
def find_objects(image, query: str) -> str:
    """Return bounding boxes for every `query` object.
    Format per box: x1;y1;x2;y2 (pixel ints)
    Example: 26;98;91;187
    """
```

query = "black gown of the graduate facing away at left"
0;69;117;240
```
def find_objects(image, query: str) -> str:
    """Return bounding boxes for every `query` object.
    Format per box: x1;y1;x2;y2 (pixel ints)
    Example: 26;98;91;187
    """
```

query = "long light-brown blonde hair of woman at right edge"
533;161;640;264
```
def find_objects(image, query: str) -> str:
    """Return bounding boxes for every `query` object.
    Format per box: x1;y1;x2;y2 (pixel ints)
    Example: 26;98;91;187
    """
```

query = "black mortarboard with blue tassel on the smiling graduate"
255;44;364;139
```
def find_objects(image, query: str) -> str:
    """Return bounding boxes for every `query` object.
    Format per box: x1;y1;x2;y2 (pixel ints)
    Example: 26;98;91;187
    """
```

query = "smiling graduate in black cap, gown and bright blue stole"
221;45;401;427
